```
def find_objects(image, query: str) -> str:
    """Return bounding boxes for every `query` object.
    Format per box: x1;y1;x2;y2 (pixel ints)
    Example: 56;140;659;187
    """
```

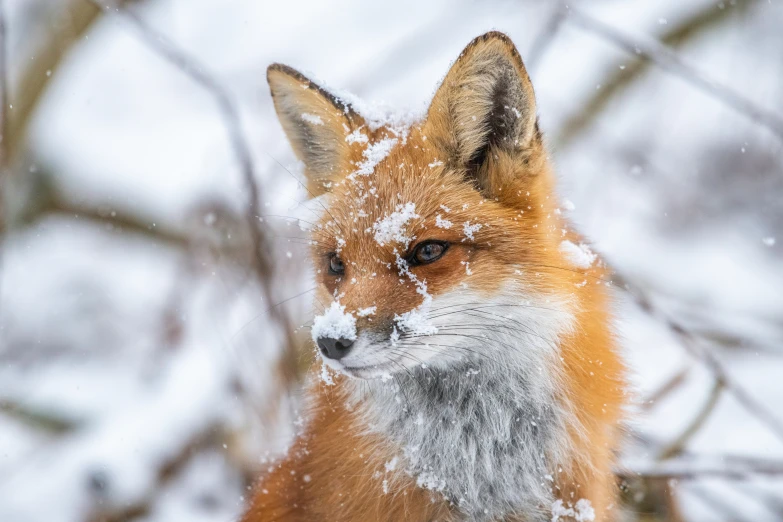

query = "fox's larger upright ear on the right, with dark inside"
425;32;539;190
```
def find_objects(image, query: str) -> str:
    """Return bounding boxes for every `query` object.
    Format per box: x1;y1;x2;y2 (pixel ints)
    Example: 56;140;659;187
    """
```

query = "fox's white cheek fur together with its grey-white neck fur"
348;284;579;521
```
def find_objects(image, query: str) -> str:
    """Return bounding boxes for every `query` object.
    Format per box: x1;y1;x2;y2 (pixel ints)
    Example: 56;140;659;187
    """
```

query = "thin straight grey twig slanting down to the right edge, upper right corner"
567;9;783;139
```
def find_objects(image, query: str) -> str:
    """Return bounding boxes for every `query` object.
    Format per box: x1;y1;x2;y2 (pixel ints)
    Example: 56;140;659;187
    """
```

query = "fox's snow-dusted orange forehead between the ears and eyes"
315;128;506;262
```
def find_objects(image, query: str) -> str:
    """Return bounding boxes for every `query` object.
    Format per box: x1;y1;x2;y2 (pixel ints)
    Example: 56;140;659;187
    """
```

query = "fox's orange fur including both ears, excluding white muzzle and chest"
248;33;624;522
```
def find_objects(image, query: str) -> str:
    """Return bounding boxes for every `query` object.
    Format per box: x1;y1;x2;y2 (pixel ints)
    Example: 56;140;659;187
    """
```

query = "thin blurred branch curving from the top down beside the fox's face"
86;0;298;412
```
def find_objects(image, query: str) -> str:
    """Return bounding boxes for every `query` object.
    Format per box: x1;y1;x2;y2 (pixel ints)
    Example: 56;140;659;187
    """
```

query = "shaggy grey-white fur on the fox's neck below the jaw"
349;296;574;520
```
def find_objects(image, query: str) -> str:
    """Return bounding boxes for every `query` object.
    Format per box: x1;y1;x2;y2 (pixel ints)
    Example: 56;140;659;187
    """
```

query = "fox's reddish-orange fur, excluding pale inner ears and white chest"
248;33;624;522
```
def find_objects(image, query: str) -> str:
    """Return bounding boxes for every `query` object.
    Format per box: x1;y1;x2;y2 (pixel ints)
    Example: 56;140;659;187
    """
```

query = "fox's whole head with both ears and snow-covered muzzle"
268;32;582;378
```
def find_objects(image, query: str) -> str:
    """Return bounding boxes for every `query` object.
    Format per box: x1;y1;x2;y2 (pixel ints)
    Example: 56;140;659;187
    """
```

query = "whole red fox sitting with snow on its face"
243;32;625;522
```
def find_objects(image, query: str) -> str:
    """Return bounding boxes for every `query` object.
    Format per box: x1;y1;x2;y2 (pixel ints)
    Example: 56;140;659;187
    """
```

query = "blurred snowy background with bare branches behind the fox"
0;0;783;522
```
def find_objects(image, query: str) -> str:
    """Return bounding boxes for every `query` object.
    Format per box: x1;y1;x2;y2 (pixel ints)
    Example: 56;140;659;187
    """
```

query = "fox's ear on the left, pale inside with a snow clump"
266;63;364;196
